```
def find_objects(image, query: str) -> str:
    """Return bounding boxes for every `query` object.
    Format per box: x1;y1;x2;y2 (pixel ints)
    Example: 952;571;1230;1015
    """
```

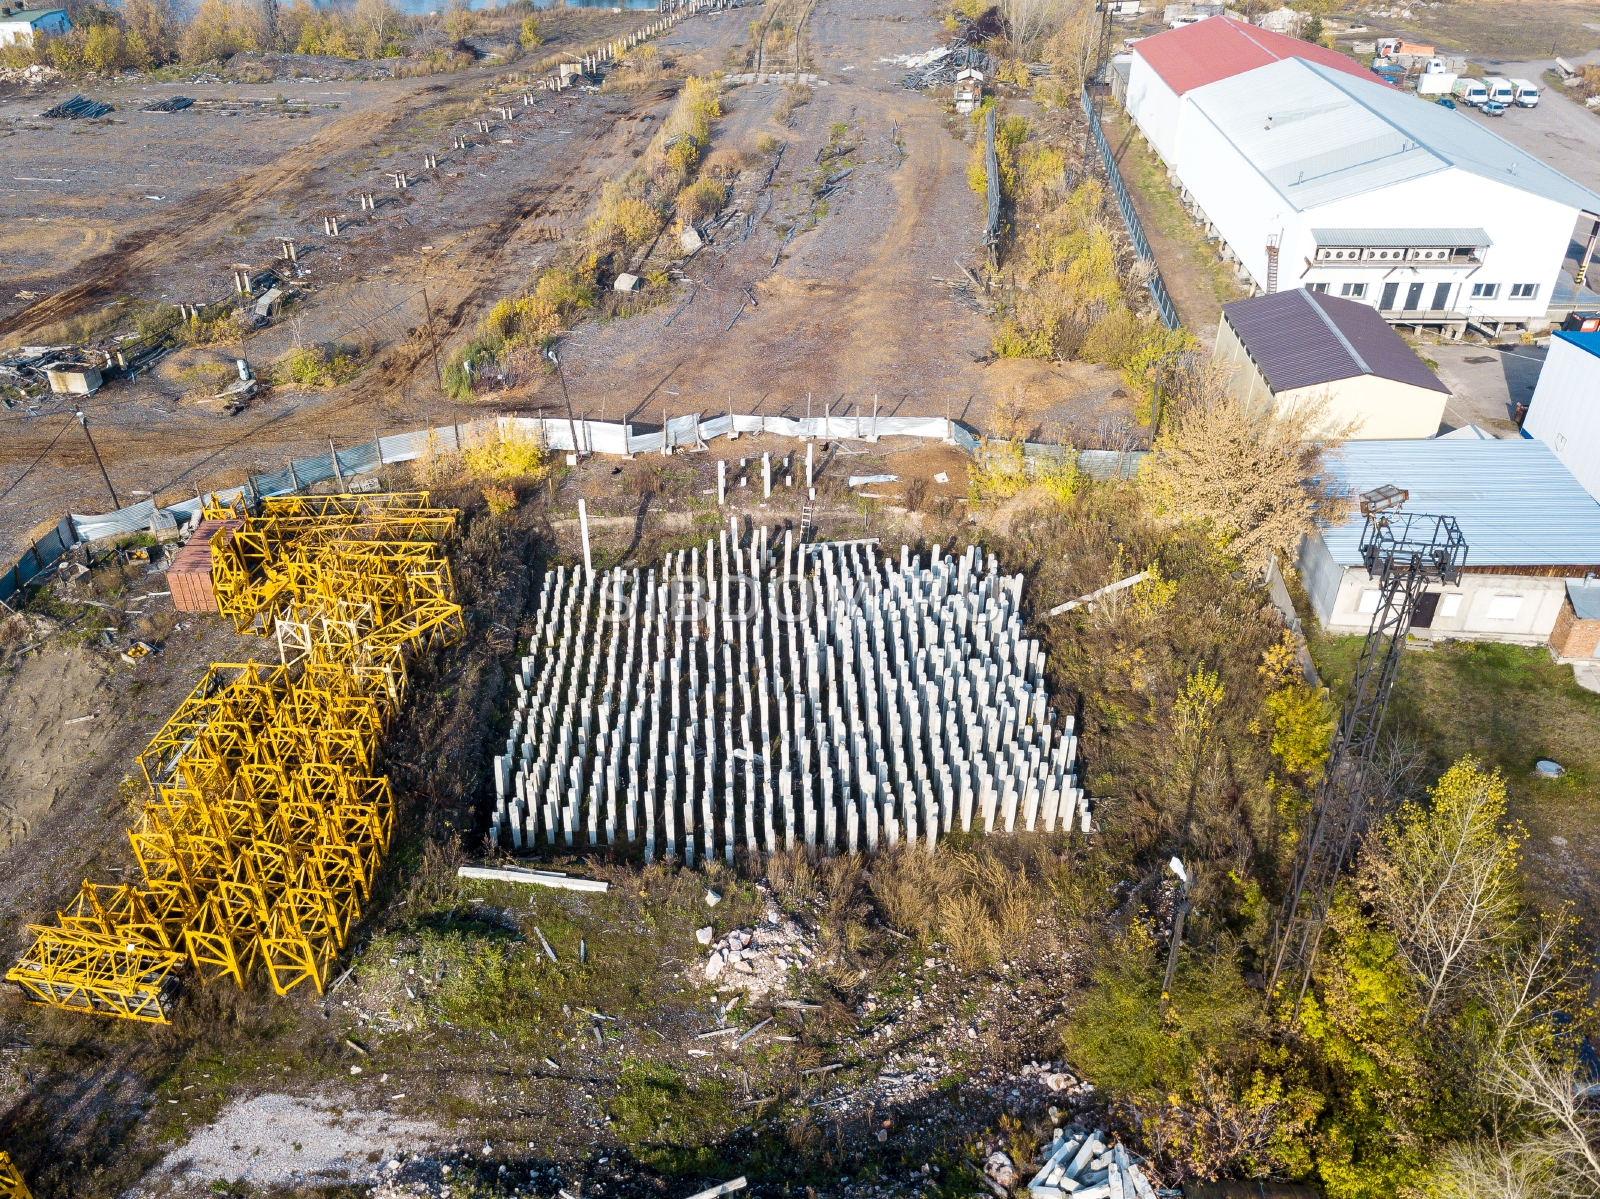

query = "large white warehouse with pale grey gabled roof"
1128;19;1600;336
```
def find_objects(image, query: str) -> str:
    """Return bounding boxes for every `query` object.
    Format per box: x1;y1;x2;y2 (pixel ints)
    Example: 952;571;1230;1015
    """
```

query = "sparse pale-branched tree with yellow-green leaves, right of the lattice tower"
1358;759;1517;1020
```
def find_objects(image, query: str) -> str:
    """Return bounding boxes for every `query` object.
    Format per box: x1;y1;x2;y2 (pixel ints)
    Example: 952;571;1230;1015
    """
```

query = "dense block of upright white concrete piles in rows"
491;519;1090;864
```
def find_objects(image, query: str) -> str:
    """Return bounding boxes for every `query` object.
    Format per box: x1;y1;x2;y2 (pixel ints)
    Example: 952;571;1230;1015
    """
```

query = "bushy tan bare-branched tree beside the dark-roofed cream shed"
1146;362;1344;568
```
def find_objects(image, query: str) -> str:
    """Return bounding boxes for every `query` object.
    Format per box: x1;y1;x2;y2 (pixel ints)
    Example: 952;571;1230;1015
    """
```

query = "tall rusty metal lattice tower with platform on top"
1267;485;1467;1015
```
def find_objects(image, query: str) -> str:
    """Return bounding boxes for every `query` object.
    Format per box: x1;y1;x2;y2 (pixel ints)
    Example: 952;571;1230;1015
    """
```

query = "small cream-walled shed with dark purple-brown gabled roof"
1216;288;1450;440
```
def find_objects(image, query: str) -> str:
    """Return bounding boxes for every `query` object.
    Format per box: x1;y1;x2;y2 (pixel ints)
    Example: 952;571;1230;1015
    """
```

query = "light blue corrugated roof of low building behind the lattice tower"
1322;439;1600;568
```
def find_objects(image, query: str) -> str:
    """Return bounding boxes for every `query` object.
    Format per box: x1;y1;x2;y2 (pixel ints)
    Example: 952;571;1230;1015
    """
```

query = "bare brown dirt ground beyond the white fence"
0;0;1109;552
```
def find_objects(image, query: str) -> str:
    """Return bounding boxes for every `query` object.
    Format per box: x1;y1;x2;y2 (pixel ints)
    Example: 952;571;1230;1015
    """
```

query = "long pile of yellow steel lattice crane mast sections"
0;493;464;1024
